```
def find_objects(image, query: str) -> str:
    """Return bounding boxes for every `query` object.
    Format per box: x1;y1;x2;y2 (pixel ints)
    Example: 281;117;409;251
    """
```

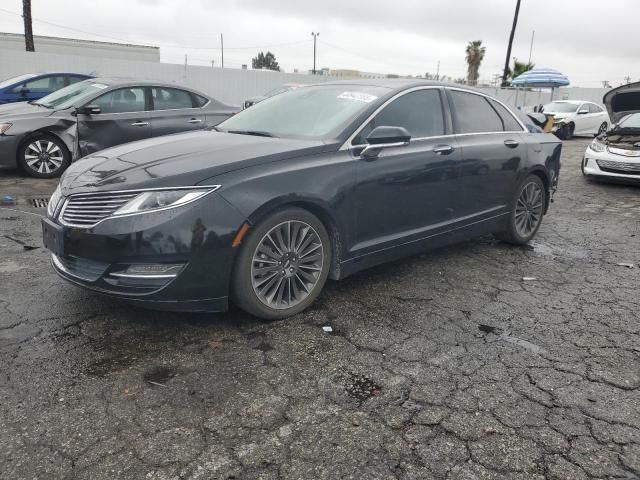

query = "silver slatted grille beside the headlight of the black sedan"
61;192;139;228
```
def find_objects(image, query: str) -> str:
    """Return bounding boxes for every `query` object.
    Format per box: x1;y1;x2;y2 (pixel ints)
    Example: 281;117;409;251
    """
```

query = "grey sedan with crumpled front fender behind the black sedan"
0;78;237;178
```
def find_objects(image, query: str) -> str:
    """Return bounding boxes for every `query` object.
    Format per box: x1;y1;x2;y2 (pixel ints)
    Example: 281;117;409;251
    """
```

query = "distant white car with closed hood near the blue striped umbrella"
542;100;610;140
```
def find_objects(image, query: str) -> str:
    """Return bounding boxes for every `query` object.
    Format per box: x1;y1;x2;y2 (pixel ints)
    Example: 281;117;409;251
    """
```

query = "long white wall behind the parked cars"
0;49;606;107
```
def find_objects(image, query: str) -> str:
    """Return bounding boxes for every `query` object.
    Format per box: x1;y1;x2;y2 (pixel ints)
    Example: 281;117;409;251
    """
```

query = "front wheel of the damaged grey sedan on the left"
17;133;71;178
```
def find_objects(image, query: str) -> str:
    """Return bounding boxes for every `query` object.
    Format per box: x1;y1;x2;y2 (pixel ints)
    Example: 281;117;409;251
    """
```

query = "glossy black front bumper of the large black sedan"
42;193;244;311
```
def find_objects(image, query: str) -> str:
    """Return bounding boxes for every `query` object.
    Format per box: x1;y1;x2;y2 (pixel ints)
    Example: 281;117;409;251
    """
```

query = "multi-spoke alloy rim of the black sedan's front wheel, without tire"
251;220;324;310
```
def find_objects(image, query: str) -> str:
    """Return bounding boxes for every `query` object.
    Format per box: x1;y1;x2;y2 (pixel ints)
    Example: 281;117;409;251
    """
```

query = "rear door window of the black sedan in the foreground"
451;90;503;133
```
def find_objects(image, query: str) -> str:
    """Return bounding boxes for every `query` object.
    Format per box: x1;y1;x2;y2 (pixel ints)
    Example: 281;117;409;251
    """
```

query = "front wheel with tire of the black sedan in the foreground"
231;208;331;320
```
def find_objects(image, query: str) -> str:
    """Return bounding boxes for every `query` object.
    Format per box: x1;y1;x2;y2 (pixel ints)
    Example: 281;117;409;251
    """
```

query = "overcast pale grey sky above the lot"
0;0;640;87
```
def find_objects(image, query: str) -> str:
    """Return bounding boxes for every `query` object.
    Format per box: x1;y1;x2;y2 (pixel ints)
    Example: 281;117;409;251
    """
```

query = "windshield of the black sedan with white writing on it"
217;85;390;140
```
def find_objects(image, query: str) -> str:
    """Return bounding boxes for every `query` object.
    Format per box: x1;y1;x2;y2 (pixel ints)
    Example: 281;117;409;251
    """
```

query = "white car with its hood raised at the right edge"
582;82;640;181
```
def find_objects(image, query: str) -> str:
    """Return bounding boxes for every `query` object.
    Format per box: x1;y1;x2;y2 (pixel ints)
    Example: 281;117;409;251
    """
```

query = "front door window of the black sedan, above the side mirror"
352;88;444;145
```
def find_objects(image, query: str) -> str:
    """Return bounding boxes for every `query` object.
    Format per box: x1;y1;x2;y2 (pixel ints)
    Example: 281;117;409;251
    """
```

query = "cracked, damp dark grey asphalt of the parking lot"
0;139;640;480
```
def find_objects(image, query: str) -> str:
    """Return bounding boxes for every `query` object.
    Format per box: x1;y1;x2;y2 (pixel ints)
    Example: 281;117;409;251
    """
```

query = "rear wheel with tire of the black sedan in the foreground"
496;175;547;245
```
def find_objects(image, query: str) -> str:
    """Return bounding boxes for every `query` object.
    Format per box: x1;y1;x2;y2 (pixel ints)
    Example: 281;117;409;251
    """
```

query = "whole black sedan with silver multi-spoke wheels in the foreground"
43;80;561;319
